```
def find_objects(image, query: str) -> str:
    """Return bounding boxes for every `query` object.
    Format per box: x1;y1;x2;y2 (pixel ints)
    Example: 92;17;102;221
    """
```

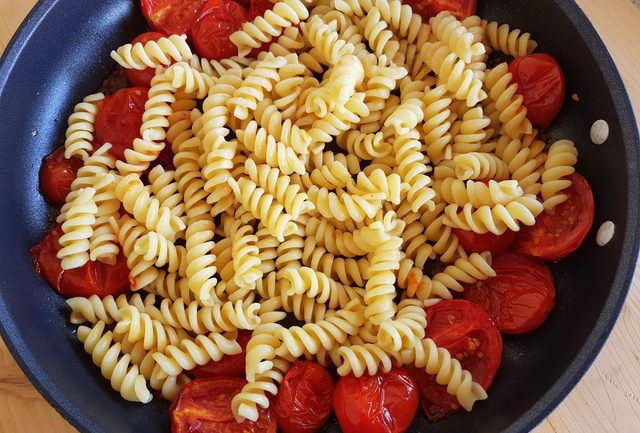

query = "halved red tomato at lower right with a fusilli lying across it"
410;299;502;422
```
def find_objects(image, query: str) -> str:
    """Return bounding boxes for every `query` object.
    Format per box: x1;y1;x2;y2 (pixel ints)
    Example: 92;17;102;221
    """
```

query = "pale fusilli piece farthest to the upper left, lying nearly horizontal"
111;35;193;71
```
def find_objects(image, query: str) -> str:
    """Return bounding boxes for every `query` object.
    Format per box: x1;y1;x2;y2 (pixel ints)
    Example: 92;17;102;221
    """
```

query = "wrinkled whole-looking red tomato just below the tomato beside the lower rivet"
464;251;556;334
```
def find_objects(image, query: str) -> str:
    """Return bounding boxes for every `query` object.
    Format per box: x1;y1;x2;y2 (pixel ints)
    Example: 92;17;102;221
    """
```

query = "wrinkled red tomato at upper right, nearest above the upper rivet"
509;53;565;128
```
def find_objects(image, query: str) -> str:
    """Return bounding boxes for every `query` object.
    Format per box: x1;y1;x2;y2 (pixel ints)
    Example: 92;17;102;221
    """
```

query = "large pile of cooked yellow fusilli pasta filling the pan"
59;0;577;421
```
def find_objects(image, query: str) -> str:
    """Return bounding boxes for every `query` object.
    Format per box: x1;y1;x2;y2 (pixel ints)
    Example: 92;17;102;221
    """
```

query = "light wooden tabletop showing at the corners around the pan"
0;0;640;433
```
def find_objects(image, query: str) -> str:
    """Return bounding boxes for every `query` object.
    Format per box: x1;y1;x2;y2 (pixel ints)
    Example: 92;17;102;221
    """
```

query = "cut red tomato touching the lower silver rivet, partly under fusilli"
514;173;594;260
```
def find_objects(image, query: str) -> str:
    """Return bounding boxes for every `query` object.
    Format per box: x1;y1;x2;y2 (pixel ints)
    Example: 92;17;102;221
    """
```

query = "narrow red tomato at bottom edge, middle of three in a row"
274;361;334;433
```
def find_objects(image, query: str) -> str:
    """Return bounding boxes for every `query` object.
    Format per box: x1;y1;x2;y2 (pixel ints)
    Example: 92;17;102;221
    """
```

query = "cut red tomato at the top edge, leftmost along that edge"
140;0;206;35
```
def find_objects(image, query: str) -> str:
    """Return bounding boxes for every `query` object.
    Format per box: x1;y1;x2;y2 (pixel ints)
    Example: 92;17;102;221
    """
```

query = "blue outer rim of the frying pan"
0;0;640;433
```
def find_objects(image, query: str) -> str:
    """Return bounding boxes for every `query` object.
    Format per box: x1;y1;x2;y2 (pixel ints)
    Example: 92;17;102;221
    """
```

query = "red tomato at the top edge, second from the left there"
192;0;247;60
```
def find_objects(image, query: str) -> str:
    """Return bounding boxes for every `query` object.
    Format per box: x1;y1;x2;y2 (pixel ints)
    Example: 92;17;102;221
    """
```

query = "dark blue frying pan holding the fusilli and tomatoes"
0;0;640;433
